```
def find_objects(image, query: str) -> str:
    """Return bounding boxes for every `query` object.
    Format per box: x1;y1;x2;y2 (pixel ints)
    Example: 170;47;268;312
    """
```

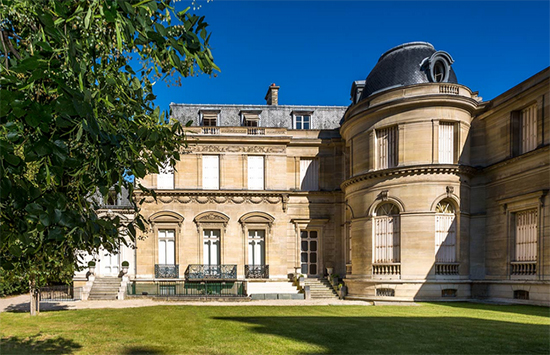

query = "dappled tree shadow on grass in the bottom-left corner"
0;333;82;354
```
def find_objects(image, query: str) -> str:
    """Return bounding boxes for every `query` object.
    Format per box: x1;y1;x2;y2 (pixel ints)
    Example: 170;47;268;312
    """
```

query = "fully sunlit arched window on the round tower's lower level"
373;203;400;264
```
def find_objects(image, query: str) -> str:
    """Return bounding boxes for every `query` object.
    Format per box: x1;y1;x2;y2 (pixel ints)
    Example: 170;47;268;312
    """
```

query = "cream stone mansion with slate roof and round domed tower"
75;42;550;305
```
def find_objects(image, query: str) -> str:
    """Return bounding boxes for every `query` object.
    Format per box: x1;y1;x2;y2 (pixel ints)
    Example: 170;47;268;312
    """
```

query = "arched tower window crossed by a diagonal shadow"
435;201;456;263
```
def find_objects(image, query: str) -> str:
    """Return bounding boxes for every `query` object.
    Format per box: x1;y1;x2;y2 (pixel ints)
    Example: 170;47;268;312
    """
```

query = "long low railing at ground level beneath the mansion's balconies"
127;281;246;298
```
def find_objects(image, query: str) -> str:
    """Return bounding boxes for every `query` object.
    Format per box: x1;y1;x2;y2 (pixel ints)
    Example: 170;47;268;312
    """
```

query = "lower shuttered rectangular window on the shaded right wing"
515;209;538;261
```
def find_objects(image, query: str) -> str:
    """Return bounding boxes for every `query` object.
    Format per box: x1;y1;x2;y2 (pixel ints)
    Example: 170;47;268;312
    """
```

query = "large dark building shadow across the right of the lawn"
215;317;550;354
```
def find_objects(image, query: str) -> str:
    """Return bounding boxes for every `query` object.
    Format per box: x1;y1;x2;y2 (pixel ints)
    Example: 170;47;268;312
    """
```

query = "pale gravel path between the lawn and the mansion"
0;295;371;312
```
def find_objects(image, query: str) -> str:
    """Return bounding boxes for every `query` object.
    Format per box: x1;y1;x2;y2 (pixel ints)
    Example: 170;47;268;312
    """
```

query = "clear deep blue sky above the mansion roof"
154;0;550;109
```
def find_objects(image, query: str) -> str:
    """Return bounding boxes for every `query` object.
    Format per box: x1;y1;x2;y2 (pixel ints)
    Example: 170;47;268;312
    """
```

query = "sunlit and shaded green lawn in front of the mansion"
0;303;550;355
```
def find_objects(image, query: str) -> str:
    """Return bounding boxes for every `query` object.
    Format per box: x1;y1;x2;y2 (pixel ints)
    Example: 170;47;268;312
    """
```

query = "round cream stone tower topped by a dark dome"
340;42;479;300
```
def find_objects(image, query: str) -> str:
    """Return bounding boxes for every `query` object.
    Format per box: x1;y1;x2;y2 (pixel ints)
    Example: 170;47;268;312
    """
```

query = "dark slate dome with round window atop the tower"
361;42;457;100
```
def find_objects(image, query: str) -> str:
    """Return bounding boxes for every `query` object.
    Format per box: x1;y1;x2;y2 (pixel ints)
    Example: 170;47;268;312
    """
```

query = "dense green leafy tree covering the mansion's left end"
0;0;218;314
